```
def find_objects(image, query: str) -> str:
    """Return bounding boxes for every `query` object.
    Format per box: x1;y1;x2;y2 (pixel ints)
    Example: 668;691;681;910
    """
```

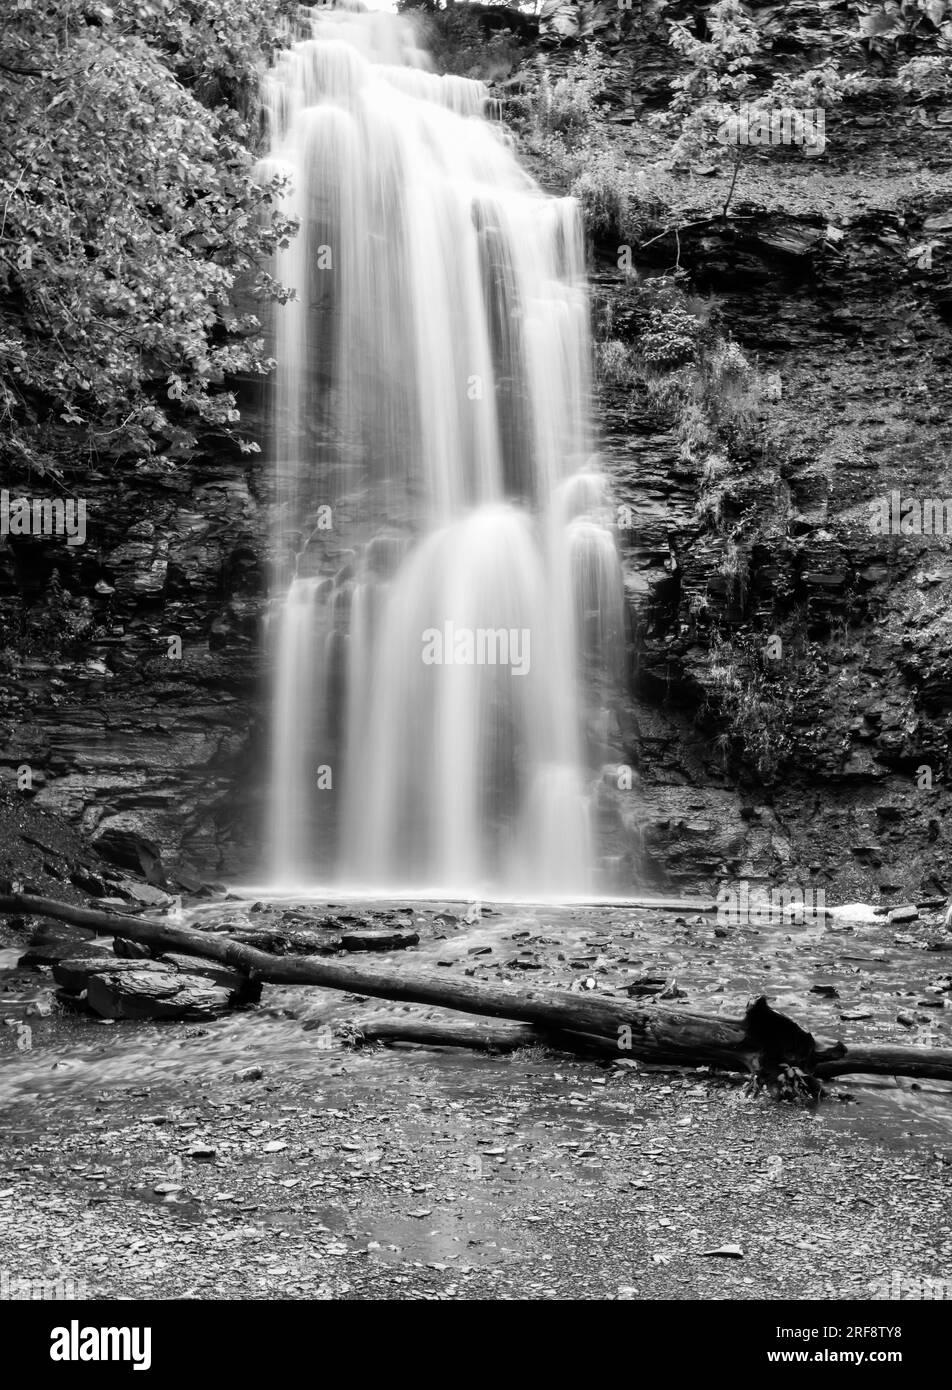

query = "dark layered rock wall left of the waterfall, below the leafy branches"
0;391;267;877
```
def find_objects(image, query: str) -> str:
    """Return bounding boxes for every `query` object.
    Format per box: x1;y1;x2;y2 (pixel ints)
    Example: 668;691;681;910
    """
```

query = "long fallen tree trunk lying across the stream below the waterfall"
0;894;952;1080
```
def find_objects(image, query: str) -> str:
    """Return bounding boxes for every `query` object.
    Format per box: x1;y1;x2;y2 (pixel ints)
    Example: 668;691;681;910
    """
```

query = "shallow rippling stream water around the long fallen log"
0;902;952;1154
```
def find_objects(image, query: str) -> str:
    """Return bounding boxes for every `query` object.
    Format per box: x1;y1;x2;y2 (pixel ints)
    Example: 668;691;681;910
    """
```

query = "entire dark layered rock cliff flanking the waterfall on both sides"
0;40;952;902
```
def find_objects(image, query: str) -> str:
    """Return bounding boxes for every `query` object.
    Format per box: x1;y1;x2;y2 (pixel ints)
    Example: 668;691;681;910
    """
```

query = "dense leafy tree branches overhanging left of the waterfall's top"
0;0;293;470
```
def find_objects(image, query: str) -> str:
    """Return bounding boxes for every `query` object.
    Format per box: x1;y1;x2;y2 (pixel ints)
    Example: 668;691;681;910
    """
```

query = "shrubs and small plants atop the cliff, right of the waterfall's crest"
523;0;952;239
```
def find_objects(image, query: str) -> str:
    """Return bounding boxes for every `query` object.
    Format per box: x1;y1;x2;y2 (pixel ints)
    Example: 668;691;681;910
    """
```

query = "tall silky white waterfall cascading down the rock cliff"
265;10;624;895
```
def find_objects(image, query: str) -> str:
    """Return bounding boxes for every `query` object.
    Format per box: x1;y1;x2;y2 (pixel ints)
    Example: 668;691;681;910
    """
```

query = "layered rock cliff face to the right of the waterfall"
595;174;952;902
